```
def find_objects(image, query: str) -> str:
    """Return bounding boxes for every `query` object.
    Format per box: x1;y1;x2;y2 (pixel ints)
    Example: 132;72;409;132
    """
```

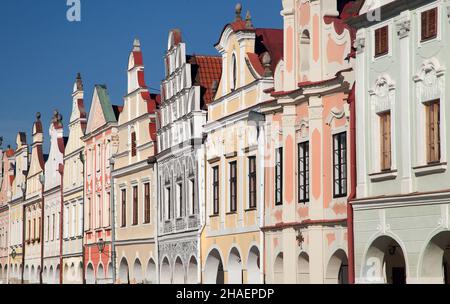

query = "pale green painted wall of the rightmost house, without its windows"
354;1;450;283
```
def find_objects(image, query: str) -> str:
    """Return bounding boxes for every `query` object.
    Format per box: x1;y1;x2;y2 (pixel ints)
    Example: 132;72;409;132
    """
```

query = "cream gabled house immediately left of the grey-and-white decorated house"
112;39;160;284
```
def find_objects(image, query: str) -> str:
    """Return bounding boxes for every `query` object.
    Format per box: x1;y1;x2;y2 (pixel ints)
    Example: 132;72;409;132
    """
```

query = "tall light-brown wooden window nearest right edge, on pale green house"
426;100;441;164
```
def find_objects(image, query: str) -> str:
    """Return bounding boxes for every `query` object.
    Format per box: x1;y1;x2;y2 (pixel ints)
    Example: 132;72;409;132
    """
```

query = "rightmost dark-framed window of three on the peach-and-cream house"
333;132;347;198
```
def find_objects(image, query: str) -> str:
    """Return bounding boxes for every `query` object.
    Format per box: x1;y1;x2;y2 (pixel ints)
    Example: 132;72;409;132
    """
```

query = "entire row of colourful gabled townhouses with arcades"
0;0;450;284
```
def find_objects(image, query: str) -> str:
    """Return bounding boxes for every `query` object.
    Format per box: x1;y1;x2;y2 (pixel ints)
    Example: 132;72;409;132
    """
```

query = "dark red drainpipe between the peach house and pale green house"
347;84;357;284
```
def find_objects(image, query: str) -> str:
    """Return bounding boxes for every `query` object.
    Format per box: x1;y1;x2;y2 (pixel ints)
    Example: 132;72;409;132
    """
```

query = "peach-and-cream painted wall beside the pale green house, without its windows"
263;1;354;284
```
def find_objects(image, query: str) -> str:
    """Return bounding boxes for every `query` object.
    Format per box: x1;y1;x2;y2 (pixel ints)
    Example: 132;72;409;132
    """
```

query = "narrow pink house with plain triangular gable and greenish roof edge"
83;85;121;284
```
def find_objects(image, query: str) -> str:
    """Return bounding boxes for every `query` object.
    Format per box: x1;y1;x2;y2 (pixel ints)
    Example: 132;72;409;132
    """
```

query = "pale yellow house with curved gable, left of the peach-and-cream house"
201;5;282;284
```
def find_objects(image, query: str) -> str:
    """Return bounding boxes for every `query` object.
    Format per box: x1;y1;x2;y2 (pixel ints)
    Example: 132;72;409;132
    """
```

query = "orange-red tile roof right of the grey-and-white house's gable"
190;55;222;107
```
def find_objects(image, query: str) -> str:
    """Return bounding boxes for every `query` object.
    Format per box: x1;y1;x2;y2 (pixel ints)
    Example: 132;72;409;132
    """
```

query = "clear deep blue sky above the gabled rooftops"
0;0;282;150
